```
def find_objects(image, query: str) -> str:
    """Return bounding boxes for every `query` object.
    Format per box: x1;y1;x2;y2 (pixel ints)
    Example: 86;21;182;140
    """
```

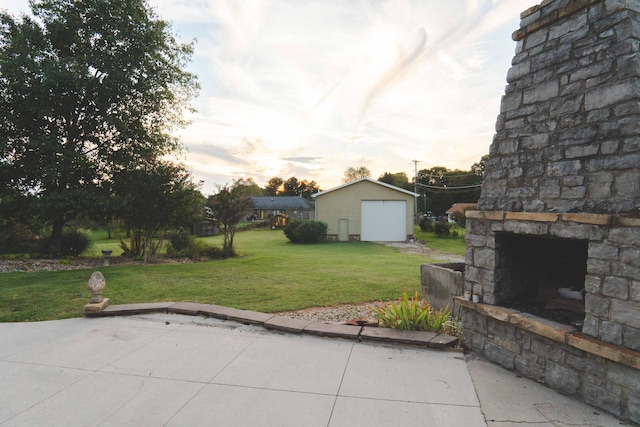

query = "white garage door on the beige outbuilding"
360;200;407;242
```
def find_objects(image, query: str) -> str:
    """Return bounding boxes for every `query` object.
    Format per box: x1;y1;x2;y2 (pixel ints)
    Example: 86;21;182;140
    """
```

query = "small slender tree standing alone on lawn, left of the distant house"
207;183;251;255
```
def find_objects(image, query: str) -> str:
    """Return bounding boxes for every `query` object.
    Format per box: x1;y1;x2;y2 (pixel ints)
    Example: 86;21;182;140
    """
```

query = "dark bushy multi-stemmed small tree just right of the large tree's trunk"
114;161;205;262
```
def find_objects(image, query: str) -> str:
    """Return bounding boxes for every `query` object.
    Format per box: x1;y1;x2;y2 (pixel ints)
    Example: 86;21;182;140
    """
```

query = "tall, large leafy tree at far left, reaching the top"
0;0;198;257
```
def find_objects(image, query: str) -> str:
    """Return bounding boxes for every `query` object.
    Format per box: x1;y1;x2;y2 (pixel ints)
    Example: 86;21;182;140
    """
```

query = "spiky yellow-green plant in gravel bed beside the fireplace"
371;291;451;332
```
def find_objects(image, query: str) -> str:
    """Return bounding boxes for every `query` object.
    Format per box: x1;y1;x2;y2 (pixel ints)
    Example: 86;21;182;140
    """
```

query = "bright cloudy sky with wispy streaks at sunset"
0;0;541;194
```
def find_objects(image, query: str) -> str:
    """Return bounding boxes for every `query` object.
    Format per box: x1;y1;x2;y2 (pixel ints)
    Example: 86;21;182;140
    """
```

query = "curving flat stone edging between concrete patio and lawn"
85;302;459;350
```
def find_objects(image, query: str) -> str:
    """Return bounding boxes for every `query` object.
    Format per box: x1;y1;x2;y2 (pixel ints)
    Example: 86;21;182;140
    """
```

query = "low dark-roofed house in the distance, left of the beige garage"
248;196;315;220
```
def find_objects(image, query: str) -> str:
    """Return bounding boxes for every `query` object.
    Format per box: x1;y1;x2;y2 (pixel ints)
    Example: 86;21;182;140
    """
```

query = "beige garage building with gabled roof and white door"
312;178;418;242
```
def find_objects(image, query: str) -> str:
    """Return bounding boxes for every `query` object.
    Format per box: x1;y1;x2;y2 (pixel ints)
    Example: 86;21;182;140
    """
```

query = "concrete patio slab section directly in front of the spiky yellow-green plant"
340;343;479;407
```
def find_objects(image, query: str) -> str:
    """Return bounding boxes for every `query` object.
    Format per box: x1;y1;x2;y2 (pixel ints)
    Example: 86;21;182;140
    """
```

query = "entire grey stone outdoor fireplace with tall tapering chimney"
456;0;640;423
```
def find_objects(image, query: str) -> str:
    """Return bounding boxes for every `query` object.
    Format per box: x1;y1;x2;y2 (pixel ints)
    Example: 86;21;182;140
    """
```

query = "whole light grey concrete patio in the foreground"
0;314;624;427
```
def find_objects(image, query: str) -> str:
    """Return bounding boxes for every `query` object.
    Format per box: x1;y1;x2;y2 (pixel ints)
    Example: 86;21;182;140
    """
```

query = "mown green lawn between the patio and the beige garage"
0;230;464;322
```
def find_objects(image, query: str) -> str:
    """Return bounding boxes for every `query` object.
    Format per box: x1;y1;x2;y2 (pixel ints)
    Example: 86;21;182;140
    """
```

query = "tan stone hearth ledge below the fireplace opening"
454;296;640;369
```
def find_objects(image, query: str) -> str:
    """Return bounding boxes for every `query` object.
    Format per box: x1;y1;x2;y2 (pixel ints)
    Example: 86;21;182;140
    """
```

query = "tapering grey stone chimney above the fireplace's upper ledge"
478;0;640;213
